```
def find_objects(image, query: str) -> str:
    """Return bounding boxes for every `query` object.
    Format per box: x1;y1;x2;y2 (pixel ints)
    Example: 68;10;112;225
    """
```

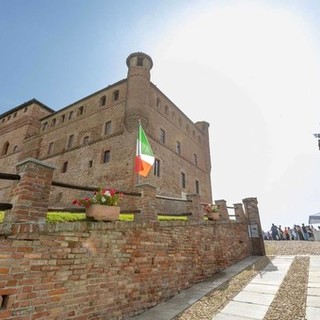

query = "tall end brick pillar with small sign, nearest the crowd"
242;198;266;256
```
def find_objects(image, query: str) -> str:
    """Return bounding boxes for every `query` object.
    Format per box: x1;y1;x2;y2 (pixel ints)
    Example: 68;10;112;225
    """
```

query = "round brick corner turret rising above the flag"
124;52;153;132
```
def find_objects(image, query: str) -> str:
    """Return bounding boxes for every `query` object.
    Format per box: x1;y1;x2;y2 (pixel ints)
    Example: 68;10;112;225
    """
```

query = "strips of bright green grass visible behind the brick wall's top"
0;211;188;223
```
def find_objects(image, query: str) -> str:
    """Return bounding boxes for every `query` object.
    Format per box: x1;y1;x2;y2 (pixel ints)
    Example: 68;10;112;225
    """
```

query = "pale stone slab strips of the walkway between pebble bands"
130;256;320;320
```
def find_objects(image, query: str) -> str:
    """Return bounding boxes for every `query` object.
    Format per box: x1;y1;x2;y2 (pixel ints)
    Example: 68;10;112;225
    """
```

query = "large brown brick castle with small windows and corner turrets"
0;52;212;203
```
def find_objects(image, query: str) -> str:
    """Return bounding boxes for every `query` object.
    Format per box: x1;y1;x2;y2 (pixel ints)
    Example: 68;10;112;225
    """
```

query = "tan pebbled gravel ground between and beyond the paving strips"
174;241;320;320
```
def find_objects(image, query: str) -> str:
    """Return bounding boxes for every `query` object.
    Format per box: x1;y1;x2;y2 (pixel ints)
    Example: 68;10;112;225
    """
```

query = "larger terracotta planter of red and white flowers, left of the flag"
72;187;122;221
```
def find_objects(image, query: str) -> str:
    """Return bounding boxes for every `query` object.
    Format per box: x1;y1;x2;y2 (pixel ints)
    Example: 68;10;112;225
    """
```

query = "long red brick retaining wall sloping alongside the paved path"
0;221;251;320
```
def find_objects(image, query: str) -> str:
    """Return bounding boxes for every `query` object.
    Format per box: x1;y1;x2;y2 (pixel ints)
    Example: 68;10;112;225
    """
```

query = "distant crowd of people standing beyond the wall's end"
264;223;316;241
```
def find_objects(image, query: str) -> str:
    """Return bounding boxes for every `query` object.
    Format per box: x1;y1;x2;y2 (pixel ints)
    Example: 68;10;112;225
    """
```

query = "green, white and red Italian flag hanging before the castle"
135;123;154;177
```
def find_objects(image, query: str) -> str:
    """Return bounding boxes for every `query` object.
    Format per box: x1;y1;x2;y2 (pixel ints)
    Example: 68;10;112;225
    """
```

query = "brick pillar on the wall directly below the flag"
134;183;158;222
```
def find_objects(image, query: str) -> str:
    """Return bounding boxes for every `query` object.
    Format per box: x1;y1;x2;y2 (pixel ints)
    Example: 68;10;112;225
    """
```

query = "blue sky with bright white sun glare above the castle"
0;0;320;229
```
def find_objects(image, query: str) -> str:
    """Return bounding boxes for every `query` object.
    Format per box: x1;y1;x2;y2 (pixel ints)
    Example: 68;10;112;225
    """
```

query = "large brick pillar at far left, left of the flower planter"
4;158;55;223
